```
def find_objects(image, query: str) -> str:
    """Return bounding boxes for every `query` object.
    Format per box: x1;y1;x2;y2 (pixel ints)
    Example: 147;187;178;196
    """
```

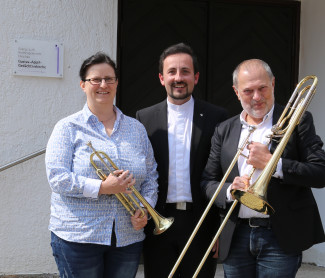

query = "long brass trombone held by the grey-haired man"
168;75;318;278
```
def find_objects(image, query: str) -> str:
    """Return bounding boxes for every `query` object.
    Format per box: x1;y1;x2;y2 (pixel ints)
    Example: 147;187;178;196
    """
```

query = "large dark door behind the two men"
117;0;300;117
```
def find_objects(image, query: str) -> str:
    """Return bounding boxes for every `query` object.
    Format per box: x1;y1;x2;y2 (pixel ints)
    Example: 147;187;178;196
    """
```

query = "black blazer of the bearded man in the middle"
136;99;227;222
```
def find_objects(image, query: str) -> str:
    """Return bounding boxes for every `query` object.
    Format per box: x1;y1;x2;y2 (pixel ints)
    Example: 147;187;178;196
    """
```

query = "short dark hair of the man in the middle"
159;43;199;74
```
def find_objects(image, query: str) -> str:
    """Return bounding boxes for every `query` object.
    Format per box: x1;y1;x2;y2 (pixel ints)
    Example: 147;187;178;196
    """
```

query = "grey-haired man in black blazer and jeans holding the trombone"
201;59;325;278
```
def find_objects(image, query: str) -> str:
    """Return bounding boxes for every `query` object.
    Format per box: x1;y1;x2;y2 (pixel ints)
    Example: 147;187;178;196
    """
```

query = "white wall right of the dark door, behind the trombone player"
299;0;325;266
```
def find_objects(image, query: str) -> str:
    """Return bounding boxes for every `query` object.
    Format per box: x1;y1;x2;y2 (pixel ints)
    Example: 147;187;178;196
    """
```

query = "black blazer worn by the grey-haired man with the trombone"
201;105;325;261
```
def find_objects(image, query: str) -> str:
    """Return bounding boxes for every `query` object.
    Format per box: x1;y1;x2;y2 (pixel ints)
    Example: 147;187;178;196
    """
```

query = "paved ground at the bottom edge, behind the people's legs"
0;264;325;278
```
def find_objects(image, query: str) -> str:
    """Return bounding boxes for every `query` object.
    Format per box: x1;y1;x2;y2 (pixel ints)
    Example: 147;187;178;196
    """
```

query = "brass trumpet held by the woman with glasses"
87;141;174;235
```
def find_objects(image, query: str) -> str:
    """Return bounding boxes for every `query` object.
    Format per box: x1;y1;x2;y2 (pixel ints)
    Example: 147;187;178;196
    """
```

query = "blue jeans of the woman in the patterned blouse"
51;233;143;278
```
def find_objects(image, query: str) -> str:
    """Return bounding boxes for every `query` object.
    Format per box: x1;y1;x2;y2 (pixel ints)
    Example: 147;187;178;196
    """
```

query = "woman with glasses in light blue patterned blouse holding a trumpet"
45;52;158;278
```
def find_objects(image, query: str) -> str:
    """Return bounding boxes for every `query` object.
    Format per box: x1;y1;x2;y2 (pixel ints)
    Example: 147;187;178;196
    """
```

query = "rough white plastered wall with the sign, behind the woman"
0;0;117;274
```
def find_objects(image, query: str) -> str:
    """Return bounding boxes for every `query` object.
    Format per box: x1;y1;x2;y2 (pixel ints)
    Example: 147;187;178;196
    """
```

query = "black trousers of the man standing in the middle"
143;206;217;278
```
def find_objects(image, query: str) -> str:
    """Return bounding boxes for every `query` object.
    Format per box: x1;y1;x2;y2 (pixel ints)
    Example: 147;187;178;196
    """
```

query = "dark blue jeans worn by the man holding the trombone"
223;224;302;278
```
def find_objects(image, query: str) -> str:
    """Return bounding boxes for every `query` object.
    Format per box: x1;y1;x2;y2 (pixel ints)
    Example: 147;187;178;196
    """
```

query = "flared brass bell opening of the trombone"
230;190;275;215
